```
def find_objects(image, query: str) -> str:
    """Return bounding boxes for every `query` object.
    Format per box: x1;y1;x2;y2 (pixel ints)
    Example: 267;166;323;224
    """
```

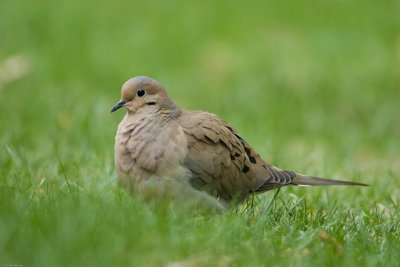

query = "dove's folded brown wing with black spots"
180;111;295;200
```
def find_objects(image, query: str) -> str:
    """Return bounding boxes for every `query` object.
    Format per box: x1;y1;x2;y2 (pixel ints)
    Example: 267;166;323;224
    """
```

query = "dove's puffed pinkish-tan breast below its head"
115;113;187;184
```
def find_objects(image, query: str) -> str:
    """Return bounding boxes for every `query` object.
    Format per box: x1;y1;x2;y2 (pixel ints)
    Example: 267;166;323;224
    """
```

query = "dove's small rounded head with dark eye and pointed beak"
111;76;176;114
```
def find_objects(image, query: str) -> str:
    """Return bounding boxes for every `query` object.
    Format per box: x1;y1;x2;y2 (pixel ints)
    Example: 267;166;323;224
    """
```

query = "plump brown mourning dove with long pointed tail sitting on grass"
111;76;365;209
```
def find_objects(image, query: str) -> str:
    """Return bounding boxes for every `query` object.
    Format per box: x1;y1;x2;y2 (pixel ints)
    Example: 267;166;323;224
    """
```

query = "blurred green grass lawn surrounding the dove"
0;0;400;266
